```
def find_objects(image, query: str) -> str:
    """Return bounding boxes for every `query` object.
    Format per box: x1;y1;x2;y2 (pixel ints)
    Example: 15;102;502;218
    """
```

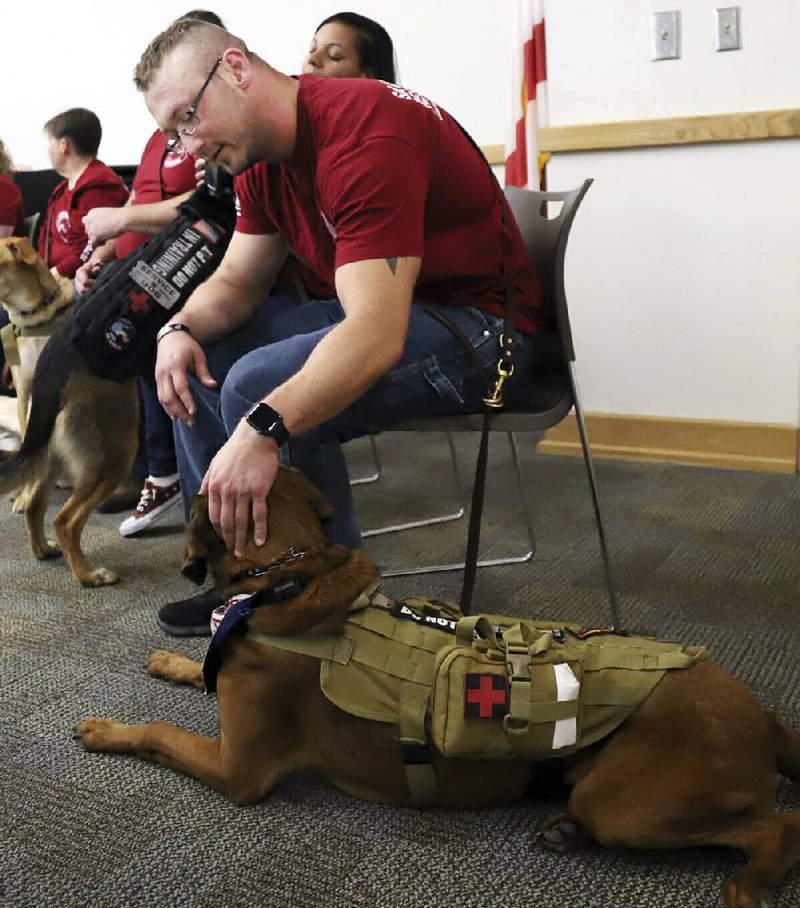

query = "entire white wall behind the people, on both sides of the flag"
6;0;800;425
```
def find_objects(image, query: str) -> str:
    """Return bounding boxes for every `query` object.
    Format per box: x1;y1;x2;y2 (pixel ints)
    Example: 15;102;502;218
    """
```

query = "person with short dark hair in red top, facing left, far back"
38;107;128;277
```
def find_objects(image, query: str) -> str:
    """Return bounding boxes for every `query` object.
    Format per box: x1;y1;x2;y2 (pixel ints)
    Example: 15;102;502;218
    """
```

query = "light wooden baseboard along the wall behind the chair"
539;413;800;473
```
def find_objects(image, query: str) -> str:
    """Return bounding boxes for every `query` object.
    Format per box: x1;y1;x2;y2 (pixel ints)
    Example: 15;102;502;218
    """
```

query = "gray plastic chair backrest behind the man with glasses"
505;179;593;361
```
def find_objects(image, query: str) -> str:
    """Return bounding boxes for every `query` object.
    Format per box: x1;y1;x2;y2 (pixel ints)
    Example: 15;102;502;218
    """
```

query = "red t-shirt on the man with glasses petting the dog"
236;75;551;332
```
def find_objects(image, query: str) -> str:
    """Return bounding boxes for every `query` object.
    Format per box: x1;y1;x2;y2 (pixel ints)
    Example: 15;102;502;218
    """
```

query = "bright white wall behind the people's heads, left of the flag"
0;0;511;168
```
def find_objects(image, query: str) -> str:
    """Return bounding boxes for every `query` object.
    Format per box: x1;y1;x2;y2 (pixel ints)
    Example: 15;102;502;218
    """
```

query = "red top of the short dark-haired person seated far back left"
38;158;128;277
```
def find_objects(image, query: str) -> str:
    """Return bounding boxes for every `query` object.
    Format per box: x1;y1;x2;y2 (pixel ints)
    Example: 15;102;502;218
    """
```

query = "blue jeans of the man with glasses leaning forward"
175;293;548;548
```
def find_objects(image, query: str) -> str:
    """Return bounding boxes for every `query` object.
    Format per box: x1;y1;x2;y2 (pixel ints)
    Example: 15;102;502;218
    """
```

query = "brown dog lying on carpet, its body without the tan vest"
75;469;800;908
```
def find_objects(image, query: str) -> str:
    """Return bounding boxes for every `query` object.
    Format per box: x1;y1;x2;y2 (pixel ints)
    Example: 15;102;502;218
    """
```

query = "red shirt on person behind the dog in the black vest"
115;131;195;259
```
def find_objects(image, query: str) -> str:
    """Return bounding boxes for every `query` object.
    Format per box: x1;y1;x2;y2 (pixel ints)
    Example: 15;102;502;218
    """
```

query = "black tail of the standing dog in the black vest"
0;320;72;495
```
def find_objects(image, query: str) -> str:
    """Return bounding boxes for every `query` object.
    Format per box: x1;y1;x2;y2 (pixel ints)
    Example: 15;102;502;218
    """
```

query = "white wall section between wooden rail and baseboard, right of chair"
549;141;800;425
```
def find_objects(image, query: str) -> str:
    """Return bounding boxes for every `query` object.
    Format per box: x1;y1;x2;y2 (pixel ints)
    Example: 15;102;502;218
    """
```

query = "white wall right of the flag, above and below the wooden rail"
547;0;800;425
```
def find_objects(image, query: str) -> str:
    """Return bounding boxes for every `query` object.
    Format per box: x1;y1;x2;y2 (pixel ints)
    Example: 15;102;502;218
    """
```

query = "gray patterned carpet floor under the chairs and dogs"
0;436;800;908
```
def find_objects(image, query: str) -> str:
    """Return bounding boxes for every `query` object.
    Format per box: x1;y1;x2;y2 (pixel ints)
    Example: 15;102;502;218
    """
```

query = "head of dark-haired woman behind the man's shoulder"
303;12;397;82
